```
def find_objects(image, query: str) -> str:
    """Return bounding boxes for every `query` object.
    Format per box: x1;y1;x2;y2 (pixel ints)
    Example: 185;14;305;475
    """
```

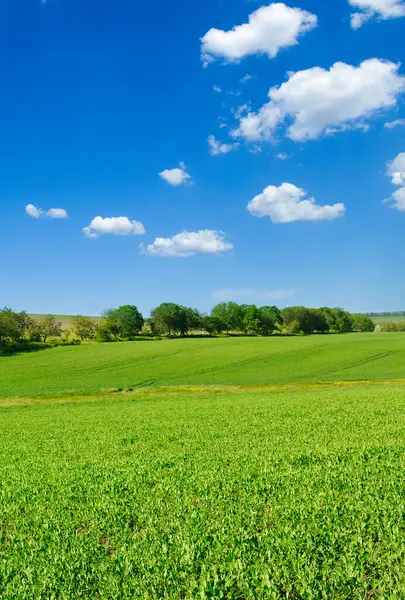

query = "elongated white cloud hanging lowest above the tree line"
141;229;233;258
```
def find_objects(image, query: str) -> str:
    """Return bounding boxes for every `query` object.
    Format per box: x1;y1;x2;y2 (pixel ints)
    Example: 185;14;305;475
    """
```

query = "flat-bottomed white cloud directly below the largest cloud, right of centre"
247;183;345;223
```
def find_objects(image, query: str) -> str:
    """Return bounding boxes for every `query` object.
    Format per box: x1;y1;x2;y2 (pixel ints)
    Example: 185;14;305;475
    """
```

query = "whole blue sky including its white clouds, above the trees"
0;0;405;314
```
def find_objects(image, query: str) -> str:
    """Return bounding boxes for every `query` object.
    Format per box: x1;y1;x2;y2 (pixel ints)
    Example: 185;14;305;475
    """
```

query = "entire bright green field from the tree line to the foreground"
0;333;405;600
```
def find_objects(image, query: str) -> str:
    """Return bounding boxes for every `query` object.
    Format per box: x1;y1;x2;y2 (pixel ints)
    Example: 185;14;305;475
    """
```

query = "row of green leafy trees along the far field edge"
0;302;375;352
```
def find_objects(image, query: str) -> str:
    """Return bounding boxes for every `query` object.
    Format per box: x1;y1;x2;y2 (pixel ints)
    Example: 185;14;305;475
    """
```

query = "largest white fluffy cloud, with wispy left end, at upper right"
232;58;405;141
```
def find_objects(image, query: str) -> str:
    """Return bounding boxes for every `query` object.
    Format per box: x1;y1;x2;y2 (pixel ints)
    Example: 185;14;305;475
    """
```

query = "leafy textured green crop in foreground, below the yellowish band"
0;384;405;600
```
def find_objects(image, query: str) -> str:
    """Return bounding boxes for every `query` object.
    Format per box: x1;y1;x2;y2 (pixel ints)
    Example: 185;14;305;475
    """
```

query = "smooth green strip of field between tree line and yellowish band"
0;333;405;397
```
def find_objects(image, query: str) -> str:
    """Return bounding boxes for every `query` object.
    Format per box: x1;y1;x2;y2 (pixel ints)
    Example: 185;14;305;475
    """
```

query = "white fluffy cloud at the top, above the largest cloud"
201;2;317;65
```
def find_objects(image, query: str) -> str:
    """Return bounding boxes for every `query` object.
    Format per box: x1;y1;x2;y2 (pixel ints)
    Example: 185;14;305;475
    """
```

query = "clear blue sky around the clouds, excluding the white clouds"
0;0;405;314
